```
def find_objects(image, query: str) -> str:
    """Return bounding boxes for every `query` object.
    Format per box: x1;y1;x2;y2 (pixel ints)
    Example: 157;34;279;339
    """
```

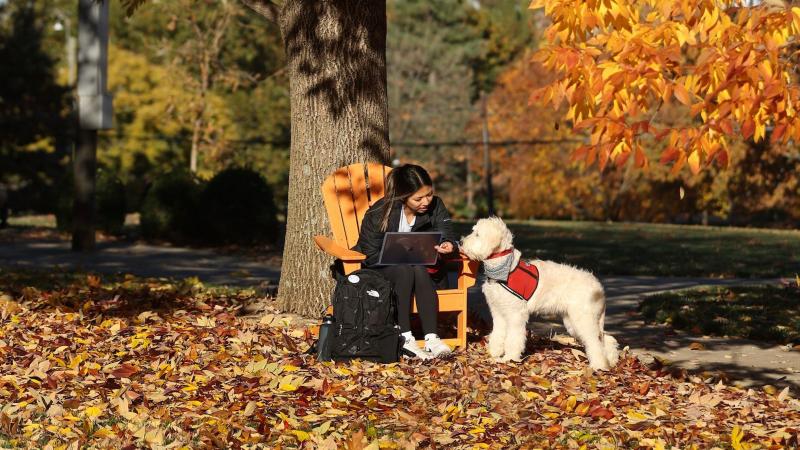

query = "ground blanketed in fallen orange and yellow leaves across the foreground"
0;272;800;449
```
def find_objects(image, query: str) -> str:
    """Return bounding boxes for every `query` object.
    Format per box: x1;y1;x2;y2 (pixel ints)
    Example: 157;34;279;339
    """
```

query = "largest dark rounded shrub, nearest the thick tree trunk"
201;168;277;244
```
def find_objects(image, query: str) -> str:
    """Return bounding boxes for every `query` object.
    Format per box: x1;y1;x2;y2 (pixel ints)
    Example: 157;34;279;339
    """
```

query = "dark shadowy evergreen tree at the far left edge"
0;1;71;212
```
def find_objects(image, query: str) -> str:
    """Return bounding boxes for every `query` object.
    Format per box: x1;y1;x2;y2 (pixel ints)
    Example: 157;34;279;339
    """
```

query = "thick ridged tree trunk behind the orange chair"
278;0;389;315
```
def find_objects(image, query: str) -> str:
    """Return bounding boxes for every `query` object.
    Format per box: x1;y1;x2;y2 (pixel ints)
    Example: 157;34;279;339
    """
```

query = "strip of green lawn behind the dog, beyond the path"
455;221;800;278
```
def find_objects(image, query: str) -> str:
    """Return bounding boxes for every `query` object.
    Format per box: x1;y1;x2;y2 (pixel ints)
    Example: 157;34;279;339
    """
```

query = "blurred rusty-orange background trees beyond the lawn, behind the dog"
476;55;736;222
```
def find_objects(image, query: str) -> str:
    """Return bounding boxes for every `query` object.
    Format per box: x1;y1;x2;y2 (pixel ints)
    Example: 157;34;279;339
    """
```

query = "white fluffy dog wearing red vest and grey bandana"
460;217;619;370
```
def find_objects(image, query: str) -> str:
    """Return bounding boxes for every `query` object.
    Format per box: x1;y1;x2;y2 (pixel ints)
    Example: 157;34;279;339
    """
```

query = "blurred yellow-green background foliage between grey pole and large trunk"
107;2;289;215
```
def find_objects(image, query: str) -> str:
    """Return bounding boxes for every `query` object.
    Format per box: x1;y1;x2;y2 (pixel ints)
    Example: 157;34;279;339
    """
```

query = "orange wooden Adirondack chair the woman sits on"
314;163;477;347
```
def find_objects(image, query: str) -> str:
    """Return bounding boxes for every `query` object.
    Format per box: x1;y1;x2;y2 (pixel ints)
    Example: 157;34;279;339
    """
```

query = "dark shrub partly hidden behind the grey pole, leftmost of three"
55;170;126;234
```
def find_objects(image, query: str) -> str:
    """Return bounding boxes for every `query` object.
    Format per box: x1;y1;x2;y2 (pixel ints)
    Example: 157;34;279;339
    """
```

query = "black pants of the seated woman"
377;265;439;334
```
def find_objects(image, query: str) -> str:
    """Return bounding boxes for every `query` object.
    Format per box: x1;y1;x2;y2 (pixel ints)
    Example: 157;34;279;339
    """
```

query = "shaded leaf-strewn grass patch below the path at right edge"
639;285;800;344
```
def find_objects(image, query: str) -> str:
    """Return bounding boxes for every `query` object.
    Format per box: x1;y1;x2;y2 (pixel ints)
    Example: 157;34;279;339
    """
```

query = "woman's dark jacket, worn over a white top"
353;196;458;267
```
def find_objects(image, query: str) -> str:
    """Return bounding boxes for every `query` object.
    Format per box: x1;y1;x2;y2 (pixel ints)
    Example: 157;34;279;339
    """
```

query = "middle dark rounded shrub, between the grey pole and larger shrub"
140;170;202;243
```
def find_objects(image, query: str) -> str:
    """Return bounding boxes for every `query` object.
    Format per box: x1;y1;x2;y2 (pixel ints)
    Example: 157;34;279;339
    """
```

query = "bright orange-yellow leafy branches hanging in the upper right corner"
531;0;800;173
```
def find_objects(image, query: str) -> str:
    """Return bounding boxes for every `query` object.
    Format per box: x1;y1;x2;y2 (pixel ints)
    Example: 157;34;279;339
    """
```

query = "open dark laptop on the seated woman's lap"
378;231;442;266
